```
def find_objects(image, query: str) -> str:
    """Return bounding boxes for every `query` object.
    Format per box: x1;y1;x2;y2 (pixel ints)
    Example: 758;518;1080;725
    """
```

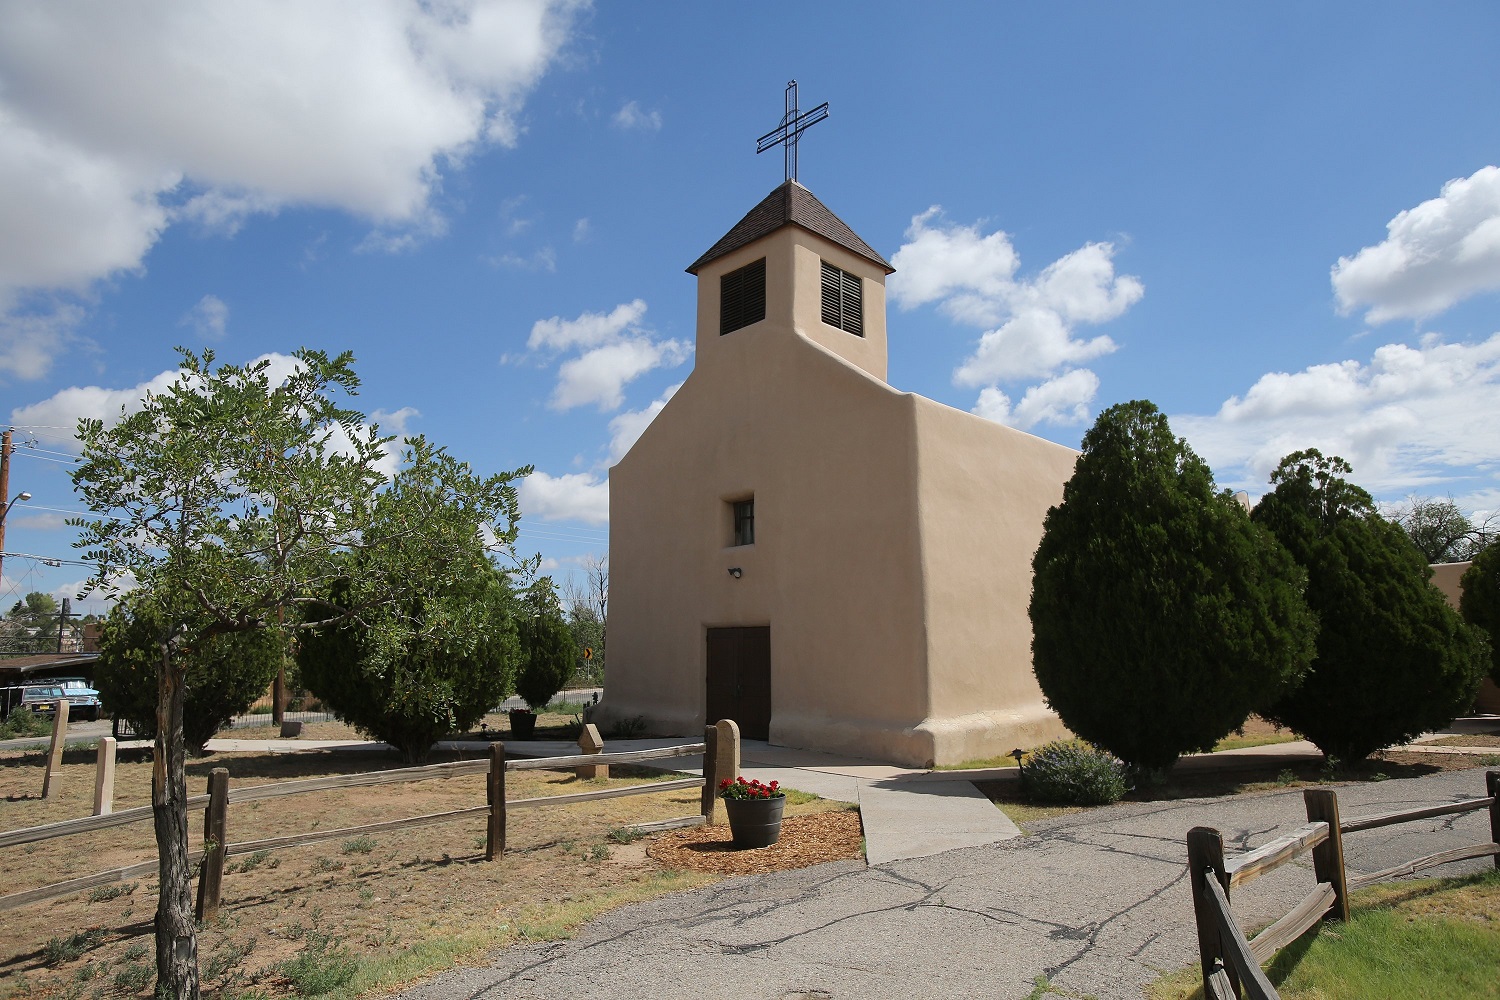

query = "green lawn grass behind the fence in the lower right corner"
1148;870;1500;1000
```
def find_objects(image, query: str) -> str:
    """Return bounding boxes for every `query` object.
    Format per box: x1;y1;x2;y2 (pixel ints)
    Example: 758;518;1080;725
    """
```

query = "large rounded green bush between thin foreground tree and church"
297;439;519;763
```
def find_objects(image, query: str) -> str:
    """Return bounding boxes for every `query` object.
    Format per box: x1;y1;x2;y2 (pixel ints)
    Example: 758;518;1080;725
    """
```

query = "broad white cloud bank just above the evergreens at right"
1172;333;1500;495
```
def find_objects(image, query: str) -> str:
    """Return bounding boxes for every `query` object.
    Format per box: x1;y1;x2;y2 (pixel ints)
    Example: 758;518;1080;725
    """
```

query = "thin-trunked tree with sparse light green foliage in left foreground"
72;349;522;1000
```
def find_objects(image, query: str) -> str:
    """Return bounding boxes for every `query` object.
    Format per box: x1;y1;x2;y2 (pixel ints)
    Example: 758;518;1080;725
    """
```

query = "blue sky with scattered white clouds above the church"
0;0;1500;610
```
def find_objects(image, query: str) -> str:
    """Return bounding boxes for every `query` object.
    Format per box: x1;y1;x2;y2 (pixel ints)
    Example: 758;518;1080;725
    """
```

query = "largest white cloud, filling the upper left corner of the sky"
0;0;584;376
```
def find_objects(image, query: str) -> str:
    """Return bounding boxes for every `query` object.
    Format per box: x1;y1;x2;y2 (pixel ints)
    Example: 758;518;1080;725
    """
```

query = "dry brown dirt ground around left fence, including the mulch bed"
0;734;861;1000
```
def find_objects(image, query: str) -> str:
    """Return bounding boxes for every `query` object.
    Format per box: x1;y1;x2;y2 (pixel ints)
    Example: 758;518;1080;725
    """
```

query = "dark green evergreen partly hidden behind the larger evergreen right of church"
1253;450;1485;760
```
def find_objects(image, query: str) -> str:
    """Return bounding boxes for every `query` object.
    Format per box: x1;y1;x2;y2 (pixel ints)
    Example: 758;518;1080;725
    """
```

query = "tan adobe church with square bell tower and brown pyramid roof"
594;174;1077;766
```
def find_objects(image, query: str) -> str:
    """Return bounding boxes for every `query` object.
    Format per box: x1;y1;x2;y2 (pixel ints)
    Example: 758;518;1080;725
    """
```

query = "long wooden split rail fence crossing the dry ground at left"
0;720;740;919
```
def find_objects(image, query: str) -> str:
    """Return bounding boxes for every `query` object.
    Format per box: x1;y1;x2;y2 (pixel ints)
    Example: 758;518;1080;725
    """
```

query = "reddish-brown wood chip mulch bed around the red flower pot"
647;811;864;876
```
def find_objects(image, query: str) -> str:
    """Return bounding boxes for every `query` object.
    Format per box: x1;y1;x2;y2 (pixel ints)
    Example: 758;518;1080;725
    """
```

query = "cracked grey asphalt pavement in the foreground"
404;771;1490;1000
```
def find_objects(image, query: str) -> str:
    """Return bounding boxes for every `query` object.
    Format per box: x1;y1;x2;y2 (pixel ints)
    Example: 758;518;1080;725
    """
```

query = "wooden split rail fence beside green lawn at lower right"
1188;771;1500;1000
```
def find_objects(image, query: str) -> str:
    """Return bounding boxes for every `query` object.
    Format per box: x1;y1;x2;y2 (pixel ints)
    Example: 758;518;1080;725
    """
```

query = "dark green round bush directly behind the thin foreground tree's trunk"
95;594;287;756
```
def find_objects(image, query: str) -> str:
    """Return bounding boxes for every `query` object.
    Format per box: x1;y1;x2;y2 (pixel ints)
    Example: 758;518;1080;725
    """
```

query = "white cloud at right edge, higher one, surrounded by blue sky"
1332;166;1500;322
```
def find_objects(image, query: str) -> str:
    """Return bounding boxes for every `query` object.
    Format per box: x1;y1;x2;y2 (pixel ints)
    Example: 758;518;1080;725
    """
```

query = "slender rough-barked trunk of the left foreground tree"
152;643;198;1000
